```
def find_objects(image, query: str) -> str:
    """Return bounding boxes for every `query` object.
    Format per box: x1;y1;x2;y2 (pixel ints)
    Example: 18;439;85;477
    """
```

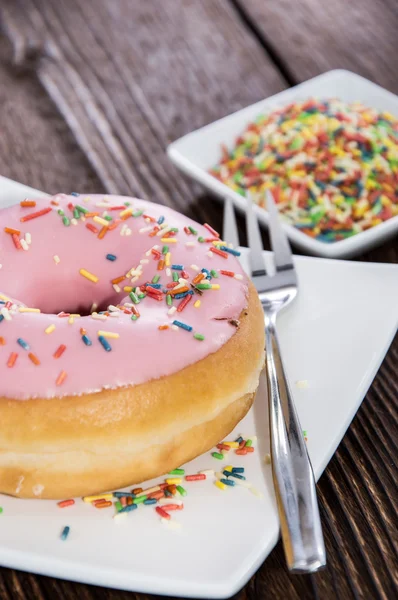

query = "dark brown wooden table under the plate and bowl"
0;0;398;600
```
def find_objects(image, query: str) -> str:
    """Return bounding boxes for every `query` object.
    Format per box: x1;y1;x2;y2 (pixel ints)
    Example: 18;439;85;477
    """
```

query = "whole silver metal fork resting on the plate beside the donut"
223;191;326;573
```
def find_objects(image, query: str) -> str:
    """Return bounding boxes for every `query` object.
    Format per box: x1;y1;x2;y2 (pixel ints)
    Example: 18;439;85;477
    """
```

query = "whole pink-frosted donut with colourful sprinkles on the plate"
0;194;264;499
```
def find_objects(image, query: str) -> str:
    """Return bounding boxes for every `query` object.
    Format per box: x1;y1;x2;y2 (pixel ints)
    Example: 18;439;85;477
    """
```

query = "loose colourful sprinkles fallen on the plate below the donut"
53;435;262;540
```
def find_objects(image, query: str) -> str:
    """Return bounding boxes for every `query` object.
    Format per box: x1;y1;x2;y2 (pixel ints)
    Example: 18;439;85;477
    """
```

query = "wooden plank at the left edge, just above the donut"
0;38;103;194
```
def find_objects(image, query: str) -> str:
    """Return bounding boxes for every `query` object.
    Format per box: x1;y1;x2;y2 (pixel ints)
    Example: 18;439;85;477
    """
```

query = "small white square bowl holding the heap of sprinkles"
167;70;398;258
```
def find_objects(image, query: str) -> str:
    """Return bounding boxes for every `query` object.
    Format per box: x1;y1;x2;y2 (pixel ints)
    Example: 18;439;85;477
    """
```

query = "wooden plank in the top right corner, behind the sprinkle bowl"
234;0;398;93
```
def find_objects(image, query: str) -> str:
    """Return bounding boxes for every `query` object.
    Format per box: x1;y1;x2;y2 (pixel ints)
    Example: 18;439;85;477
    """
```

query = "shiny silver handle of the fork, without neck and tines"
264;313;326;573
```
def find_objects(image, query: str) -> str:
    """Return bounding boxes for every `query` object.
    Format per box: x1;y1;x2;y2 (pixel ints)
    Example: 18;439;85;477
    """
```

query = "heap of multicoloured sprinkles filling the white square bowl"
210;99;398;243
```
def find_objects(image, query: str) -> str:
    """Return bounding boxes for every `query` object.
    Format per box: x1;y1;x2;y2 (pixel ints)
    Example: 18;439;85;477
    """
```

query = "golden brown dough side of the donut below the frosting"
0;284;264;498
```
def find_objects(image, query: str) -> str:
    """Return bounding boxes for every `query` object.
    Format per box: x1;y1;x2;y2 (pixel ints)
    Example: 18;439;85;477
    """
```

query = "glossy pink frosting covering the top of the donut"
0;194;247;400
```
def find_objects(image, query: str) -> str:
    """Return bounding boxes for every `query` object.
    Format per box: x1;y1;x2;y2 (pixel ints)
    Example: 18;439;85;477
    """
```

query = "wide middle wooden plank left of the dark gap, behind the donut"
0;0;285;209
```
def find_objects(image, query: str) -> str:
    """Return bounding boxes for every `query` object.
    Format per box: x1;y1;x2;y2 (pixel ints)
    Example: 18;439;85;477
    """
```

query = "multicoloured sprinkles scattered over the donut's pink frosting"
0;193;243;386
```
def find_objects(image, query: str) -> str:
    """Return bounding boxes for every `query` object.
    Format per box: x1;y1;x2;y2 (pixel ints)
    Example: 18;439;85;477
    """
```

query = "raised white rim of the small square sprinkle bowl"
167;69;398;258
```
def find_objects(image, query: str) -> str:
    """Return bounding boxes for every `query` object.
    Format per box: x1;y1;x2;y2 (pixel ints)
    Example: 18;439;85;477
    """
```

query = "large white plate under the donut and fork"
0;178;398;598
